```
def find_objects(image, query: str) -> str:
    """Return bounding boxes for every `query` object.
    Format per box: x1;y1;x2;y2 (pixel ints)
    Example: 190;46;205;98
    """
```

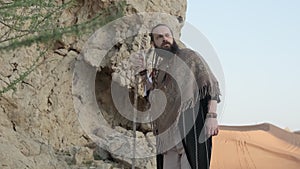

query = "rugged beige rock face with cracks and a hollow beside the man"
0;0;186;169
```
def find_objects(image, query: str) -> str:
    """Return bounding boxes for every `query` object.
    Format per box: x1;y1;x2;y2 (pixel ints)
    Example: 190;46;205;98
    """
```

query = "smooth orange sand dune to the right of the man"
211;123;300;169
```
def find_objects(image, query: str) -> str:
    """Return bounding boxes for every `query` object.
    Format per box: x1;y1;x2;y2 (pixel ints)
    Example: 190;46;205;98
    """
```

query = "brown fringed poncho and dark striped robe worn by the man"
152;49;220;169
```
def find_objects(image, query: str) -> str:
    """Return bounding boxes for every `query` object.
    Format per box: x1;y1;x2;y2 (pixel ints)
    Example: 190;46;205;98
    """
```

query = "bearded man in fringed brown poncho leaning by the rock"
131;24;220;169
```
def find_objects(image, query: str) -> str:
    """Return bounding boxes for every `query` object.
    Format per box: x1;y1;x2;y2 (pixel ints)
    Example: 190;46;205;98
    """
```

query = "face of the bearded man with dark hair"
152;26;173;50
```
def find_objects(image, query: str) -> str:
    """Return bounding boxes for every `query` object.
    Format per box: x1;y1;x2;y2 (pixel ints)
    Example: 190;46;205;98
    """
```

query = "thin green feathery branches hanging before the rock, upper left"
0;0;125;96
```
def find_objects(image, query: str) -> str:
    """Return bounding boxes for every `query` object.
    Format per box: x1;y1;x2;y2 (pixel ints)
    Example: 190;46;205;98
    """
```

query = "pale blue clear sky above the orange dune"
183;0;300;131
